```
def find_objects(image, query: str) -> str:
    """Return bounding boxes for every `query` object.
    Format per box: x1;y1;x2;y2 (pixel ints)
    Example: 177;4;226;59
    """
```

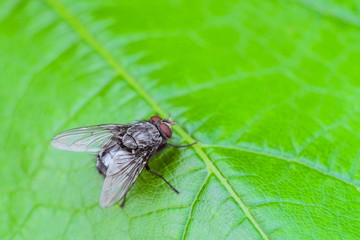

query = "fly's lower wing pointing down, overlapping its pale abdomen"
100;149;155;207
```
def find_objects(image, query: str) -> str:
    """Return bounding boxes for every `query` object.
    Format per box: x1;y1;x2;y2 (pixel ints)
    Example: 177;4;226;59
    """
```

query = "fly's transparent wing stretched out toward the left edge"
51;124;127;152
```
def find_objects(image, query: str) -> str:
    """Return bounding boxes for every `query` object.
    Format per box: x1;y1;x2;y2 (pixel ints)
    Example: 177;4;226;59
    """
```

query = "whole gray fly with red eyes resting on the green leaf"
51;116;195;207
